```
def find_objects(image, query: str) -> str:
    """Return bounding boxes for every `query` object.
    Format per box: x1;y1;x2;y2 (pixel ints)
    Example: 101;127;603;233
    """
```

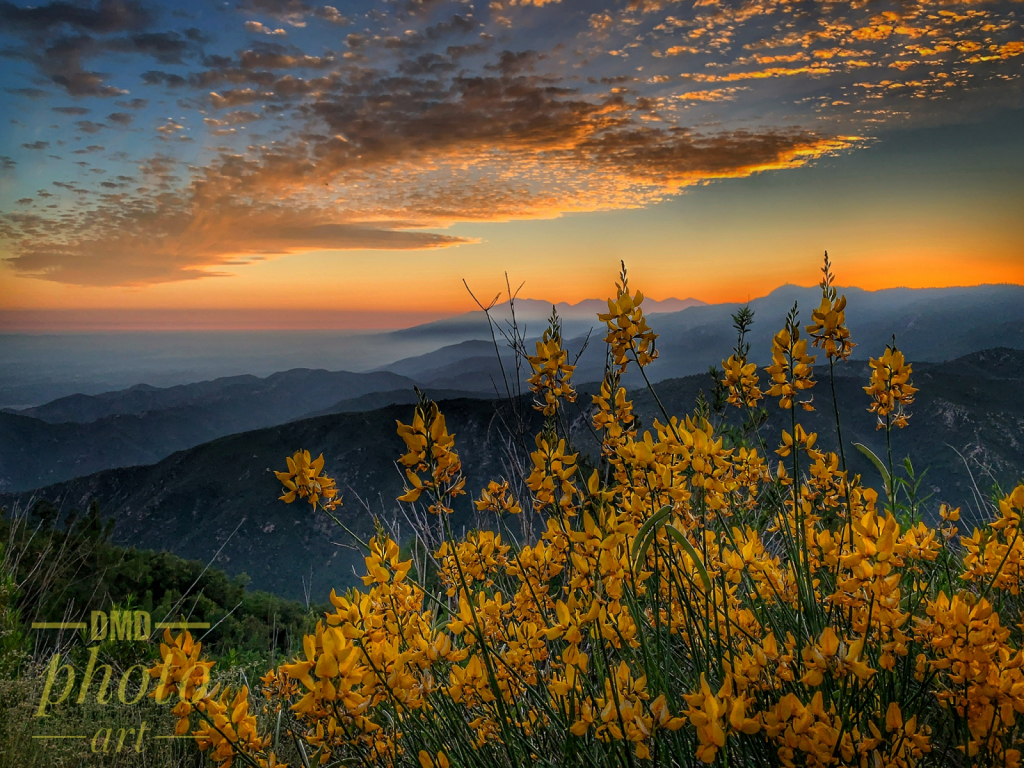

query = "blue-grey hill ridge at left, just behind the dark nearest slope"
0;369;477;492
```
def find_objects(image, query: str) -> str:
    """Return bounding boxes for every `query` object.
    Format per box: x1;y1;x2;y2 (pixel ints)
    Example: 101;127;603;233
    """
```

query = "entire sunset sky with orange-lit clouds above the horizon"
0;0;1024;331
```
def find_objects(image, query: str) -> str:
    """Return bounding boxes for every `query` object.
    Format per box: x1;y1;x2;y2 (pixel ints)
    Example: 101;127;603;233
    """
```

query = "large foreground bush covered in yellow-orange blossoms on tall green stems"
151;259;1024;768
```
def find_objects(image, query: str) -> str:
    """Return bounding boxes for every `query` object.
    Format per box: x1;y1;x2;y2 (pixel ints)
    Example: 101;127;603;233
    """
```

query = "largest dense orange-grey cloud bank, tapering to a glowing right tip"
7;56;853;285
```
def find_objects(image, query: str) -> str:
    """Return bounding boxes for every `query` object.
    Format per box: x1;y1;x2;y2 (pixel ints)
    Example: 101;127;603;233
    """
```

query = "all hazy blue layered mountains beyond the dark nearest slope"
0;286;1024;492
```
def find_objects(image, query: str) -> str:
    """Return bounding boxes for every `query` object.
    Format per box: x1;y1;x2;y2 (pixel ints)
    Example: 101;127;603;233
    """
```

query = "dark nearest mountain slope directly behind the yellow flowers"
0;349;1024;597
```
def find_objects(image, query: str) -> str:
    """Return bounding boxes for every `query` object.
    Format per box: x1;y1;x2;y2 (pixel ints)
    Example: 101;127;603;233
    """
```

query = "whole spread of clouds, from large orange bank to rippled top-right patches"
0;0;1024;285
